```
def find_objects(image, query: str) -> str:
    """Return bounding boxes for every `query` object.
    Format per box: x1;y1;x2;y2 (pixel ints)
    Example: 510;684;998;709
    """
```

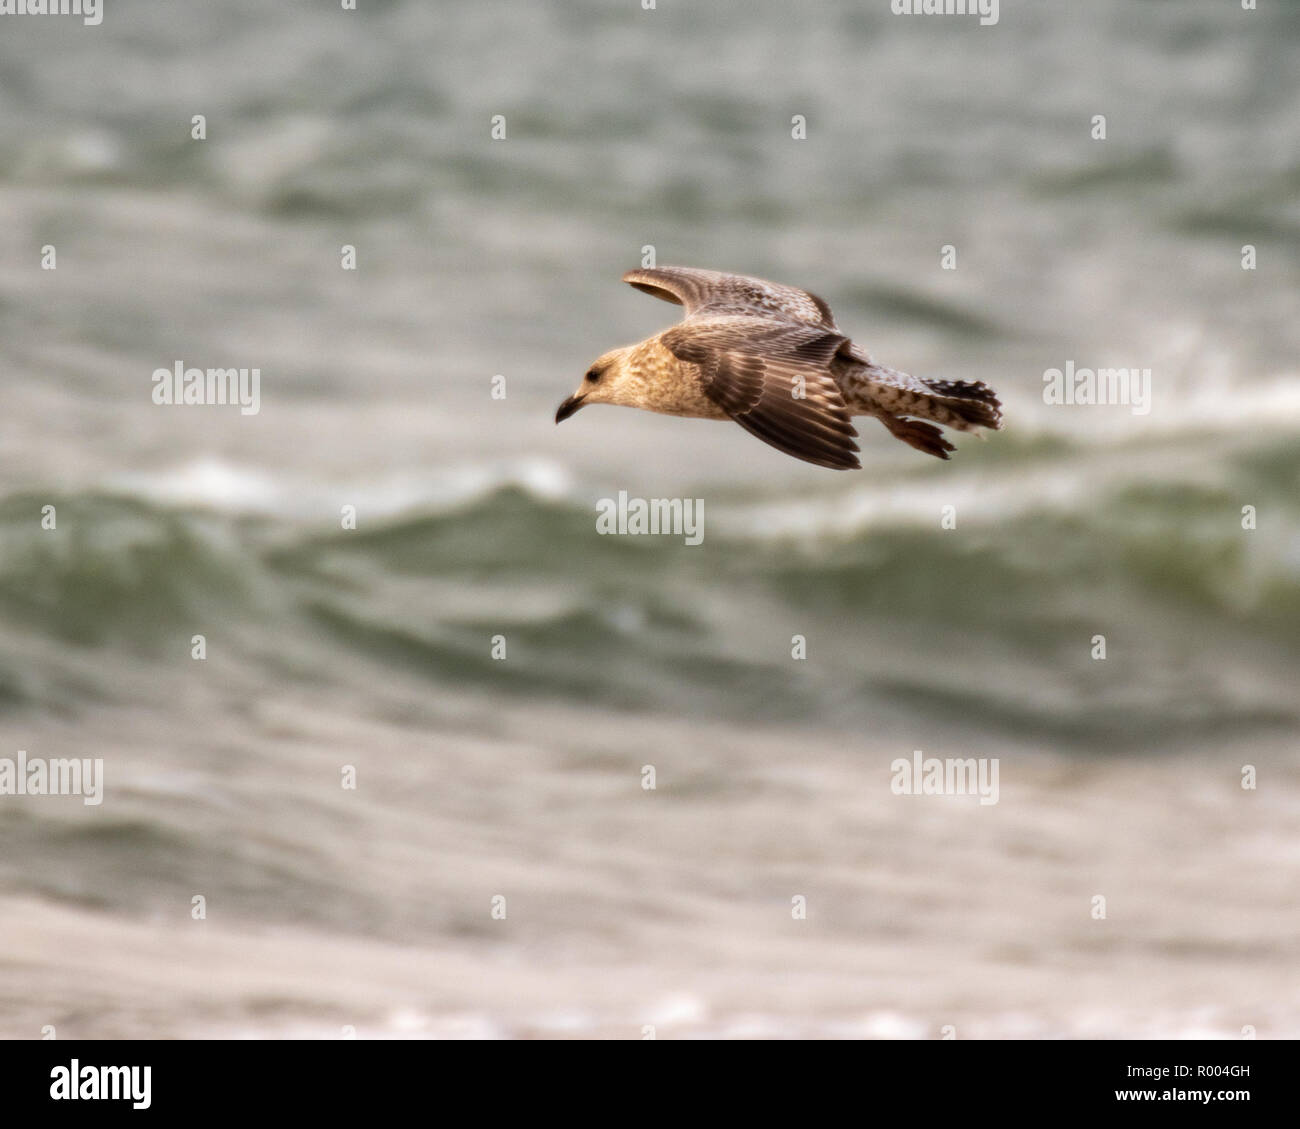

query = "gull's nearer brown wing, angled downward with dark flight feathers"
659;316;861;471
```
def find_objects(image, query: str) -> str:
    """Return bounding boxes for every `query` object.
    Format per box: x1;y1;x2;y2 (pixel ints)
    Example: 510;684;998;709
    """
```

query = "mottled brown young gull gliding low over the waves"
555;267;1002;471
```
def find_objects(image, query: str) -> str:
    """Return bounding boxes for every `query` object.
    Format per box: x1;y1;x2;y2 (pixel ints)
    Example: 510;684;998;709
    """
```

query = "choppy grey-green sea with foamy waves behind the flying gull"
0;0;1300;1038
